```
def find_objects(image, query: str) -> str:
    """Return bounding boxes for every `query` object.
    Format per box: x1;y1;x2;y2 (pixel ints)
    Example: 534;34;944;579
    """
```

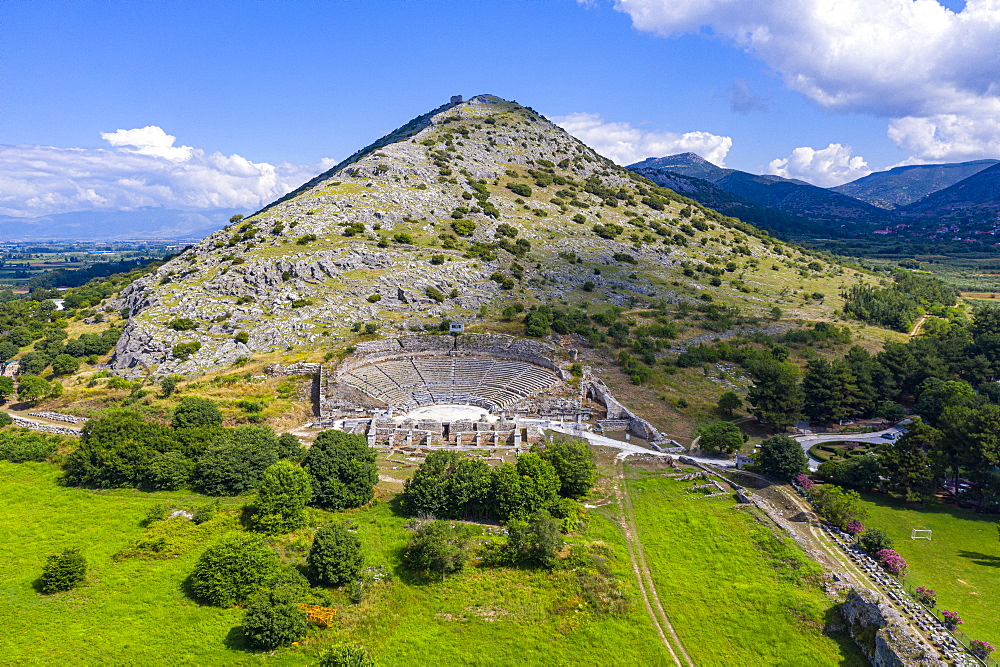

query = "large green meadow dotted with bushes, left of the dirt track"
0;462;667;665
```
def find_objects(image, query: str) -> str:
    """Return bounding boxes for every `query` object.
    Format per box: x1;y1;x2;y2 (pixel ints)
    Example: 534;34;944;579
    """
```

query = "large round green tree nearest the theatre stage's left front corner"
302;429;378;510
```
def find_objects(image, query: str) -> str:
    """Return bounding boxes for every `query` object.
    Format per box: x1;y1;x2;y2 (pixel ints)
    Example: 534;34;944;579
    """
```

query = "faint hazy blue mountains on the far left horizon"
0;208;240;241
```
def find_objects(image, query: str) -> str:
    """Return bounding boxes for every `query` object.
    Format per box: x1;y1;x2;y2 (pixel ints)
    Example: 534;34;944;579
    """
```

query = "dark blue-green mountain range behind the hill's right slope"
628;153;1000;243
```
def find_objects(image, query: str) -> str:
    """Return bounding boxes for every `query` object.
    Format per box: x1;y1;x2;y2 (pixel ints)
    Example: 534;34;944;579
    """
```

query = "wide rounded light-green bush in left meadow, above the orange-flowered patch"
190;533;278;607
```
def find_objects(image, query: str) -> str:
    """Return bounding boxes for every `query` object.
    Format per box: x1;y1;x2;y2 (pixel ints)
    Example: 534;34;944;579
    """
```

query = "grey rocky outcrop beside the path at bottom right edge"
840;588;947;667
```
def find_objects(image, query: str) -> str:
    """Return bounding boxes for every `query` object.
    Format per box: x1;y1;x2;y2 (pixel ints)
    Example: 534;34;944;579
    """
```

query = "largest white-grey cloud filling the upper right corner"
615;0;1000;159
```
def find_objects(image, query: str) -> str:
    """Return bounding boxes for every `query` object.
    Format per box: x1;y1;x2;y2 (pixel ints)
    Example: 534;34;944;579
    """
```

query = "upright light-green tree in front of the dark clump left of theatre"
253;461;312;535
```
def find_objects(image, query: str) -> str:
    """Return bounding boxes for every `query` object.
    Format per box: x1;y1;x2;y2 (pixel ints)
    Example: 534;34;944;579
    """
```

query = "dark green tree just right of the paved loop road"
879;419;945;502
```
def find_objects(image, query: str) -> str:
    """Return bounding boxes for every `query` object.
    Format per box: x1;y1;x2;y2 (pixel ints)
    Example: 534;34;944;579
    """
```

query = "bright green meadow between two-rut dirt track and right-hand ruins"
626;466;867;666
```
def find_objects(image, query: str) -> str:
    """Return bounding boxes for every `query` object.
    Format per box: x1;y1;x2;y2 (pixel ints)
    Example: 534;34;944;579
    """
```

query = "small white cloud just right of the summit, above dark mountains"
551;113;733;167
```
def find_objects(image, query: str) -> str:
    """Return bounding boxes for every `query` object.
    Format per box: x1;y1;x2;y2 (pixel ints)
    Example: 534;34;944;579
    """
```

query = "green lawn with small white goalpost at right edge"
864;494;1000;645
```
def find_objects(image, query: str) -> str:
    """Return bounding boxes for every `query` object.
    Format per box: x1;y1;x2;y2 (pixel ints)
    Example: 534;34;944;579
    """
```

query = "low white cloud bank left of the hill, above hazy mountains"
0;132;334;217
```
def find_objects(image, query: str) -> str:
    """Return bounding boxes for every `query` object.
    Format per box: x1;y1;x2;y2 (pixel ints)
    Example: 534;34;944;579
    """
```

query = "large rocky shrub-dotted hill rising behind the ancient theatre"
112;95;846;374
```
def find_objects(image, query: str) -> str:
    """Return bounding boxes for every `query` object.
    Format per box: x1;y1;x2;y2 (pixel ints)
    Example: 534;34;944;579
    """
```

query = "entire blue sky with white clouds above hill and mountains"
0;0;1000;220
